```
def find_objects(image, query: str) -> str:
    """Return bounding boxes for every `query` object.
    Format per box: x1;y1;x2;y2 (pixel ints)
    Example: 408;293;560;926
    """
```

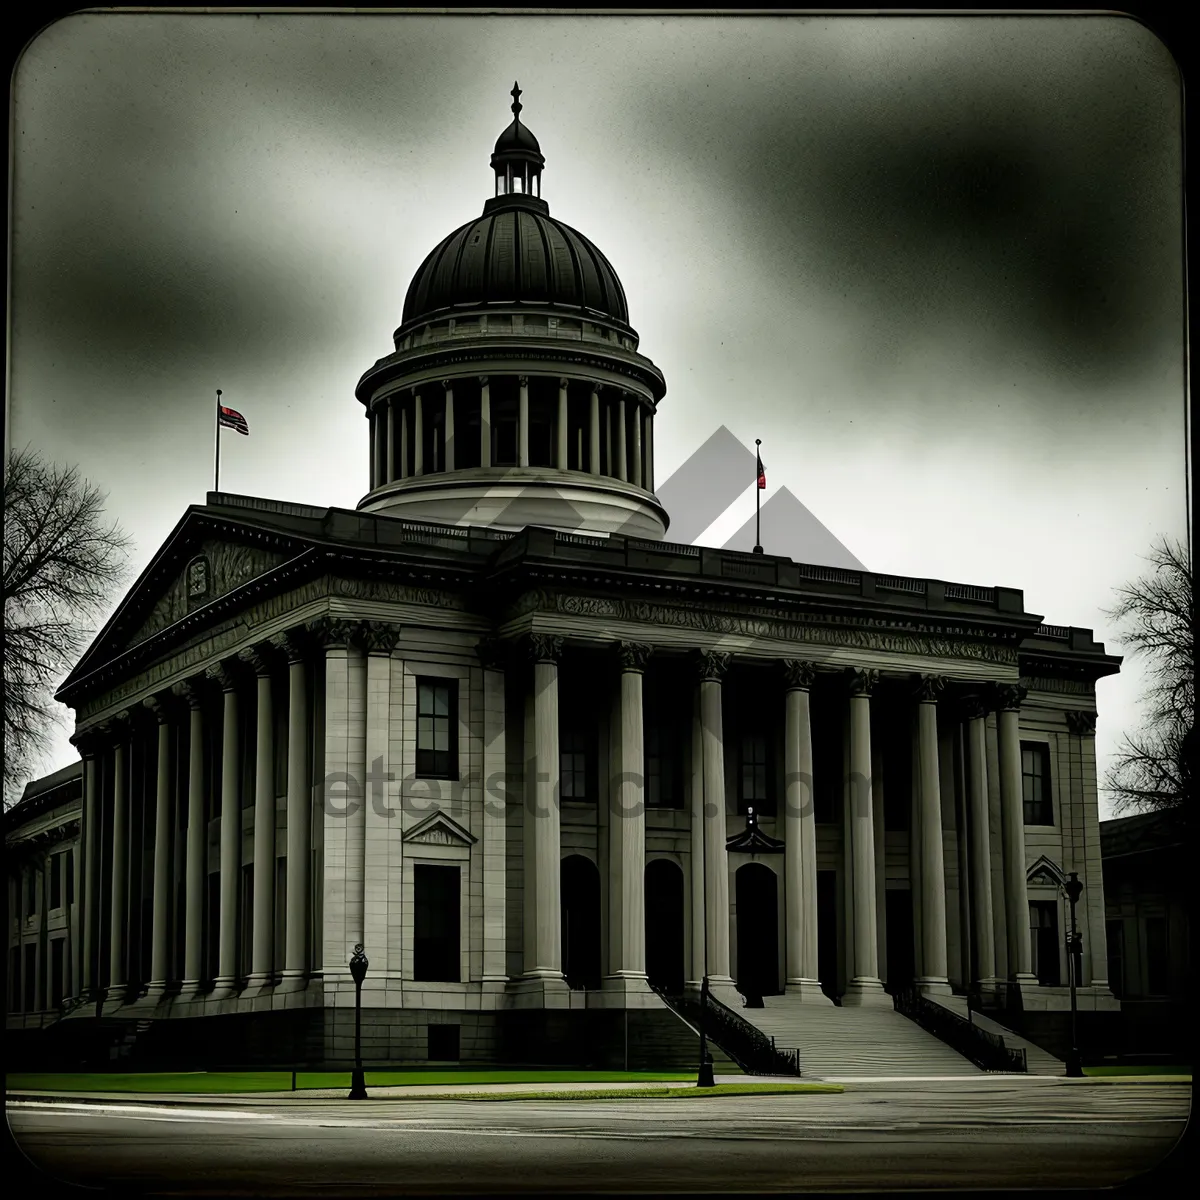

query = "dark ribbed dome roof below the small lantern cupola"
401;201;629;328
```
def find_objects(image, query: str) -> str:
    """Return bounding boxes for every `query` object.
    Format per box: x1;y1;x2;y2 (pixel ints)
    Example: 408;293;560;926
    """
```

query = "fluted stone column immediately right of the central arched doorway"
782;659;829;1003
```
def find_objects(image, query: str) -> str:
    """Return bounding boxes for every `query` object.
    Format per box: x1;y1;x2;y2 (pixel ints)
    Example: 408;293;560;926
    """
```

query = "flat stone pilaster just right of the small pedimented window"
475;638;509;991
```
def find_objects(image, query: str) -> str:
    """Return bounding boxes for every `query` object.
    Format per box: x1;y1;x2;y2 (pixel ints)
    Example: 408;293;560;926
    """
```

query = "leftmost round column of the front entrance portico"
524;634;563;980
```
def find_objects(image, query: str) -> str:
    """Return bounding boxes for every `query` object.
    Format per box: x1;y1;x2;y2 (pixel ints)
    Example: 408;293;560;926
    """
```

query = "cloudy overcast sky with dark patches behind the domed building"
7;13;1186;815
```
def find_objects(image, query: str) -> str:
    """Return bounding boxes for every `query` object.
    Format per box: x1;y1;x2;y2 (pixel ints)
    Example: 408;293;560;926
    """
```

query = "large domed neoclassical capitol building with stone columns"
8;88;1120;1074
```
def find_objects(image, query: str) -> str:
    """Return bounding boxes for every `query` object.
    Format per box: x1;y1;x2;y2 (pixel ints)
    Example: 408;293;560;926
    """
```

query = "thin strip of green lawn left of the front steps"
5;1068;696;1093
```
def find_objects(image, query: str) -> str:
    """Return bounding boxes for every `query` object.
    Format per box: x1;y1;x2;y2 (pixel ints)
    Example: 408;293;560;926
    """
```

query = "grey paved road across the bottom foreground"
8;1078;1190;1196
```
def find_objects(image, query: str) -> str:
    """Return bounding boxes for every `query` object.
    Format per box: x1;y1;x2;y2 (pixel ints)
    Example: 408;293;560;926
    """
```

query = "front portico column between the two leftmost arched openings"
606;642;652;992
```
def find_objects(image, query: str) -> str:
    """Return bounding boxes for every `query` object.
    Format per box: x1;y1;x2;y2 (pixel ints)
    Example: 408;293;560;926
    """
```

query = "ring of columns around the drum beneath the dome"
367;374;654;492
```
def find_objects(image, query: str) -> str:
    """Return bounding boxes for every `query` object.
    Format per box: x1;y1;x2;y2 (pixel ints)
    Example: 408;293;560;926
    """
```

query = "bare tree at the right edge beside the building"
1106;538;1195;815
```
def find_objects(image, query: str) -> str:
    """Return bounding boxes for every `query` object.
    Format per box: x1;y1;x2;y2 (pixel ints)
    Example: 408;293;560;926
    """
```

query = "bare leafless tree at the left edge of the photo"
4;448;130;808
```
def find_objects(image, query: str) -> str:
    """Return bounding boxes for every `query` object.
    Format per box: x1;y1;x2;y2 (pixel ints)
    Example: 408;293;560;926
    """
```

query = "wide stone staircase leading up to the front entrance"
739;996;984;1079
